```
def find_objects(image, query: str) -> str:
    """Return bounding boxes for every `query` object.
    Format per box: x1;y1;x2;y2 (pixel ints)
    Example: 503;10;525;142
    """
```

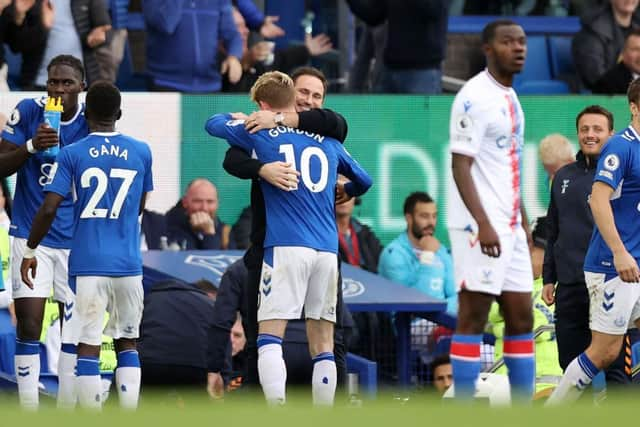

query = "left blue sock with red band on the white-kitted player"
451;334;482;400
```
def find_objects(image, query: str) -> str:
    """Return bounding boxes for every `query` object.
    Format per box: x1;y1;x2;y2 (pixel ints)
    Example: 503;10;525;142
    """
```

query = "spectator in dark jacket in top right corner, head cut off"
571;0;640;90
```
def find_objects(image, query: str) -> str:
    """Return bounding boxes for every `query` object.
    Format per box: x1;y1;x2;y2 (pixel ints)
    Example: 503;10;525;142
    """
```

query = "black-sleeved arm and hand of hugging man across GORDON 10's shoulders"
245;108;349;142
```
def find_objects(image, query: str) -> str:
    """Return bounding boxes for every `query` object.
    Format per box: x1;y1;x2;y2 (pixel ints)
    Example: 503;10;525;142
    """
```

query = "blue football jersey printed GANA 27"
44;132;153;277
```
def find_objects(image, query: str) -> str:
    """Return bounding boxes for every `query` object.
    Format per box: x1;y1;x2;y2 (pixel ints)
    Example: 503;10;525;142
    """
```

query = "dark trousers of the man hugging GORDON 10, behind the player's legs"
244;246;347;386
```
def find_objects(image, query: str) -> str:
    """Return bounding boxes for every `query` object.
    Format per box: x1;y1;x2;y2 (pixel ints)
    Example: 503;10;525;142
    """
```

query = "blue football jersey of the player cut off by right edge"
584;126;640;275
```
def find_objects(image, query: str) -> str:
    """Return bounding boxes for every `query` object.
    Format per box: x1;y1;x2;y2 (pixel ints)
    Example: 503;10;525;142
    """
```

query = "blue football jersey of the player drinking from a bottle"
2;97;89;249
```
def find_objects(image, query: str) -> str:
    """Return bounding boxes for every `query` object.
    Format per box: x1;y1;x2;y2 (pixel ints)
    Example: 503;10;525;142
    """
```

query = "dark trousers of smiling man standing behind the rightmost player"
555;283;639;384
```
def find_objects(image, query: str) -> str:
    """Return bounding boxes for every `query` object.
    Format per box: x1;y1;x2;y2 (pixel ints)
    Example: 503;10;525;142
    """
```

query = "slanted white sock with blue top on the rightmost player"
545;353;599;406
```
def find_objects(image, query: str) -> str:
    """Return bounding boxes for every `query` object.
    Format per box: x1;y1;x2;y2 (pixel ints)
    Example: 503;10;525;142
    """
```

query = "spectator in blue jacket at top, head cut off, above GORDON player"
142;0;242;93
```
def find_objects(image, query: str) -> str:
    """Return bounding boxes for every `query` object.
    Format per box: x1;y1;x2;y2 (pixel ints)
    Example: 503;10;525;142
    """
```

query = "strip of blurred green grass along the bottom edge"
0;392;638;427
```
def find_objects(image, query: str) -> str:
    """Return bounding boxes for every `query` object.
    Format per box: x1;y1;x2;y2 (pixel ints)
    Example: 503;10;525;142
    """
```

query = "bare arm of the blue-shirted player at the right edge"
589;181;640;282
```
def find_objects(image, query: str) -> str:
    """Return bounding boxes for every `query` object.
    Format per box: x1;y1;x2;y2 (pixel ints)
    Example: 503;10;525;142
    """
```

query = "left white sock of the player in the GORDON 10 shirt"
258;344;287;405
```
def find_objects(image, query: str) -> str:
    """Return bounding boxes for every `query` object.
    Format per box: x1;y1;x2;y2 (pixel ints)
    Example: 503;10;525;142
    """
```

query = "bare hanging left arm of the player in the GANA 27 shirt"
20;192;64;289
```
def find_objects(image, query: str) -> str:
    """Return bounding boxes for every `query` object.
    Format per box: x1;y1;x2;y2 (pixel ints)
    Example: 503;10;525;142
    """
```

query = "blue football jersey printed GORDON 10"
206;114;371;253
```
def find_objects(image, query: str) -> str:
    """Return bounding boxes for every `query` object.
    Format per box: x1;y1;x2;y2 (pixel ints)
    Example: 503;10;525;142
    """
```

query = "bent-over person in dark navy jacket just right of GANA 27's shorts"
138;280;217;387
